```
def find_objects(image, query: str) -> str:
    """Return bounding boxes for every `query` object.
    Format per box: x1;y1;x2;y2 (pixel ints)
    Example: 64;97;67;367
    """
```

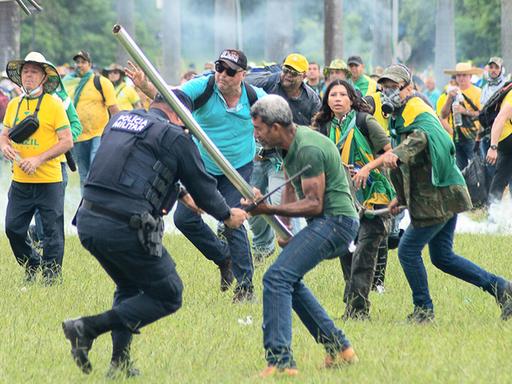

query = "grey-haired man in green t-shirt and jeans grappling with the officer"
242;95;359;377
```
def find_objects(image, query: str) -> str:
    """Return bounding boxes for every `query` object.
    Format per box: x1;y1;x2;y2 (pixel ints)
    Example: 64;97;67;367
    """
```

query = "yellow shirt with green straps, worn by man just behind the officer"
66;76;117;142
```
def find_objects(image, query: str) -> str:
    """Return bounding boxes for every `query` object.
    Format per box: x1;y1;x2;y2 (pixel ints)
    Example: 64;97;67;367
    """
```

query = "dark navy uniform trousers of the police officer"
77;208;183;360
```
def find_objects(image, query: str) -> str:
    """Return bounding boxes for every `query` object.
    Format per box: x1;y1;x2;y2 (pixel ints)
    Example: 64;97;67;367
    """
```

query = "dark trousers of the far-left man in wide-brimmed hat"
5;181;64;275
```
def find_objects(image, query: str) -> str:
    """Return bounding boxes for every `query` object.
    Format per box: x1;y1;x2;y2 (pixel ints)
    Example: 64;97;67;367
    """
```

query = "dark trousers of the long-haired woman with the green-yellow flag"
340;217;391;316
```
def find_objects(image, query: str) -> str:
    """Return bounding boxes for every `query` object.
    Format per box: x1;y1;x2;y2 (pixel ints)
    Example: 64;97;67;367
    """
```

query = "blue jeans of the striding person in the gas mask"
398;215;506;309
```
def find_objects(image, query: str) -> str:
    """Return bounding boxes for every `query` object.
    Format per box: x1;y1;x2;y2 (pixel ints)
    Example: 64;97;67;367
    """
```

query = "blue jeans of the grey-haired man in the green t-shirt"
263;216;359;367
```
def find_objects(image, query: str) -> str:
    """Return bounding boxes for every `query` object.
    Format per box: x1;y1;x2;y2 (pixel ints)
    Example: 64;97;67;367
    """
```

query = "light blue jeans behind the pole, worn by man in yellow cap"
249;160;300;251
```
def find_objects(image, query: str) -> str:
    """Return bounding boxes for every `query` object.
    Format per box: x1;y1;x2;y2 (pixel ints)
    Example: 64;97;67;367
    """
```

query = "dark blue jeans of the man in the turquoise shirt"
174;162;254;288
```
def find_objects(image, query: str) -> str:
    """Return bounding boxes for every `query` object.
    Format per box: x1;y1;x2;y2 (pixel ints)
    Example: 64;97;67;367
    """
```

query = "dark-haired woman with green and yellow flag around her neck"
313;80;395;319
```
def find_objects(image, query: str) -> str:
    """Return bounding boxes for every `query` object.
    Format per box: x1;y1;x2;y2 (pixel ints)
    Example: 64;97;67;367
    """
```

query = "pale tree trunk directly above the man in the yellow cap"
265;0;293;63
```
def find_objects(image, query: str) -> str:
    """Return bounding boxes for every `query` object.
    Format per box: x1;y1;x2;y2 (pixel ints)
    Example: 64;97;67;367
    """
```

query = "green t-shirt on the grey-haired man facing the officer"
283;125;358;217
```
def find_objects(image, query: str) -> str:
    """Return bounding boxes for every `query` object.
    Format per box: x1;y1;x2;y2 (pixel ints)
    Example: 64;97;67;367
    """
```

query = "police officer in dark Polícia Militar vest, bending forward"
62;90;247;376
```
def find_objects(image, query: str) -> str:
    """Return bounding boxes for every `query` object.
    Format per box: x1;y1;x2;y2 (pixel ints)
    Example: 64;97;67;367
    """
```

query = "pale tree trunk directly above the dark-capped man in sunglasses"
214;0;239;58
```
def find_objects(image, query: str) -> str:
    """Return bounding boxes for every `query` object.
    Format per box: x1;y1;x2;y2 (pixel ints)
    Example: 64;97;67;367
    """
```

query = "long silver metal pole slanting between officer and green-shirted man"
112;24;293;240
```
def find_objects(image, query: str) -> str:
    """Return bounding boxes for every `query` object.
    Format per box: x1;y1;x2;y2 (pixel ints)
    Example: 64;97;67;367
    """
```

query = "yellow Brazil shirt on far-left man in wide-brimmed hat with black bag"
4;94;70;183
